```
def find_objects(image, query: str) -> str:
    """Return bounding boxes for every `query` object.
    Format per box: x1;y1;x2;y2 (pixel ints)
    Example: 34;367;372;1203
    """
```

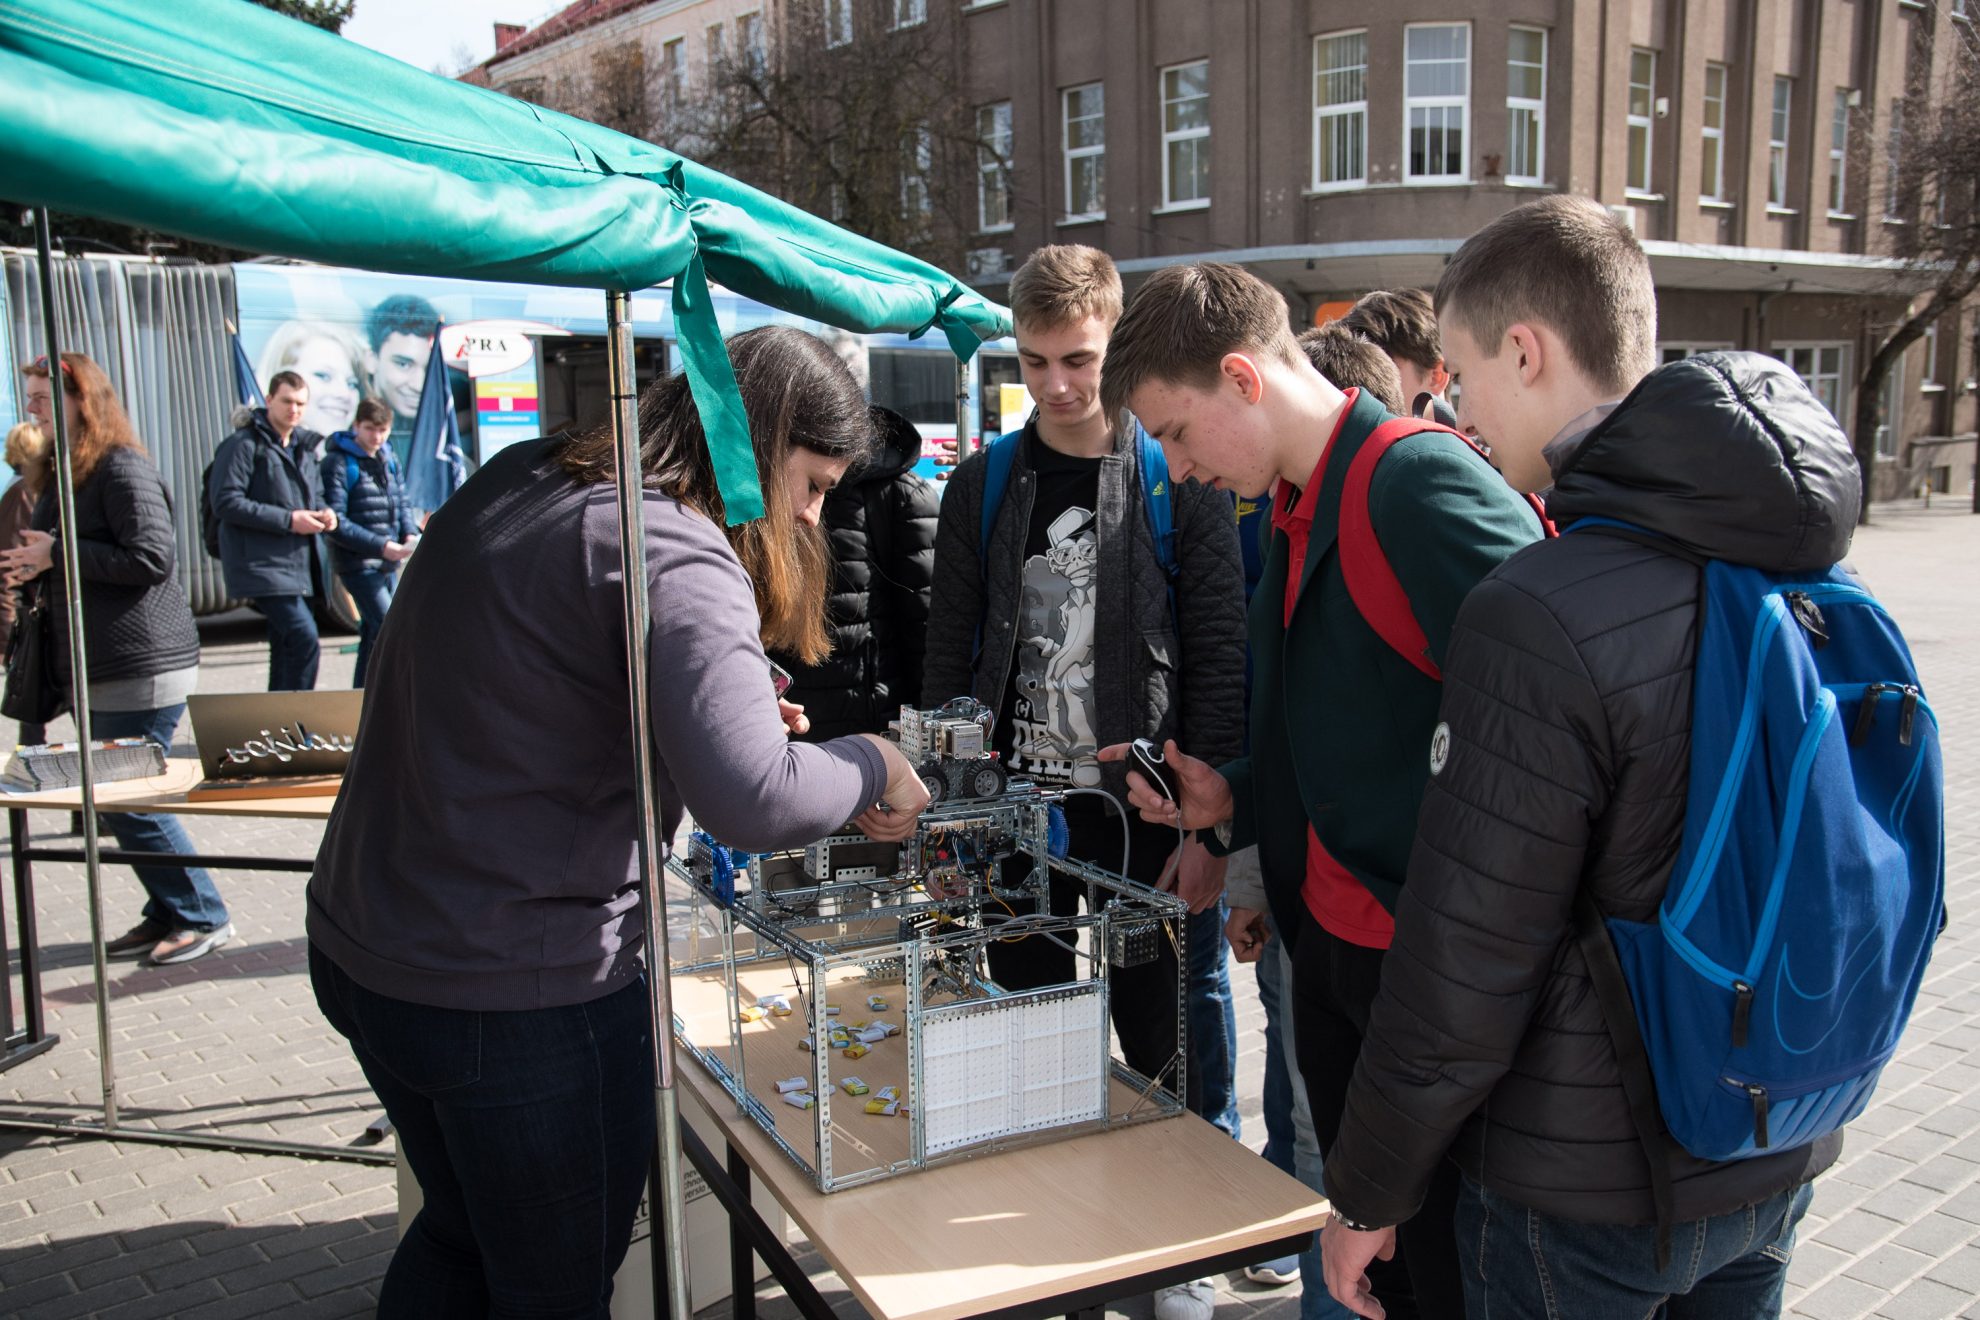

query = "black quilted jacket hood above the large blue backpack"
1546;352;1861;572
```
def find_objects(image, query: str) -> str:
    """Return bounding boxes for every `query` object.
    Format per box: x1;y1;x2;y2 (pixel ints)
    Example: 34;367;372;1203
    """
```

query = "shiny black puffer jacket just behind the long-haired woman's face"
772;408;941;742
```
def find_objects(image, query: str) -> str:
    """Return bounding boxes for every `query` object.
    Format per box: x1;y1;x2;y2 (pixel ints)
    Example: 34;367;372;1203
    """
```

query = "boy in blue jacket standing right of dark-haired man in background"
321;398;420;687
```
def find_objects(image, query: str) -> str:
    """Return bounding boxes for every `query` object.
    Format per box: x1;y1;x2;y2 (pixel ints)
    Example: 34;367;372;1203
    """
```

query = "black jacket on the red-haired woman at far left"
34;449;200;685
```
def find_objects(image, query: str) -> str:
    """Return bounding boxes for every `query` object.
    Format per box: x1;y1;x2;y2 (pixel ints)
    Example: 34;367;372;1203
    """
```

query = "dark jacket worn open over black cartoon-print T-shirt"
921;422;1243;800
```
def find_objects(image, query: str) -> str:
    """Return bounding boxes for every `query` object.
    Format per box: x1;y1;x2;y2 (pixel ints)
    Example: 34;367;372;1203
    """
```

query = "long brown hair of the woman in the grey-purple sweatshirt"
558;325;873;665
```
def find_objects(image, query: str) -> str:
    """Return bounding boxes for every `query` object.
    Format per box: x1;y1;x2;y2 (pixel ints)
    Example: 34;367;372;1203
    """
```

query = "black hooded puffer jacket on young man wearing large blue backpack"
1327;352;1859;1223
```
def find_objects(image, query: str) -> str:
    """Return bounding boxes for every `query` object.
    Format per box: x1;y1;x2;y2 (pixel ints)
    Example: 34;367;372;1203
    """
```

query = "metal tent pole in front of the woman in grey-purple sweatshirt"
606;293;693;1320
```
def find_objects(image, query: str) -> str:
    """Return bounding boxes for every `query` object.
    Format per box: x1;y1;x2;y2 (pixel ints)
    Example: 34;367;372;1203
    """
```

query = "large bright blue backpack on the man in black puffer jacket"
1570;519;1944;1239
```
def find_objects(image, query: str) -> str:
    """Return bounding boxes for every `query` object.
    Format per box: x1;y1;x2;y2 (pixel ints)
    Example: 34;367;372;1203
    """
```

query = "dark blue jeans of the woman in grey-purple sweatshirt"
309;944;653;1320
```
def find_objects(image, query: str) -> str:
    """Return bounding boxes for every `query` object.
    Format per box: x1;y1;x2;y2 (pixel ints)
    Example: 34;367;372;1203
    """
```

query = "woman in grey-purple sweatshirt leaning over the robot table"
309;327;927;1318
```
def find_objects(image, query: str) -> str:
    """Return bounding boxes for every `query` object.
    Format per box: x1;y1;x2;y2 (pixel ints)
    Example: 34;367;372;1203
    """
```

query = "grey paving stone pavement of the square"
0;505;1980;1320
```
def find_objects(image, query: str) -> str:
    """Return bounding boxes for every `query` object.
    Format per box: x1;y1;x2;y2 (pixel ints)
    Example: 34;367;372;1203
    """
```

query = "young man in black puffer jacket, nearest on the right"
1323;196;1853;1320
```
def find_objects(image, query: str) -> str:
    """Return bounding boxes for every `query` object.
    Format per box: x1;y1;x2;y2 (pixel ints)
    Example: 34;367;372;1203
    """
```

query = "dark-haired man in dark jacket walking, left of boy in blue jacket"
208;372;337;693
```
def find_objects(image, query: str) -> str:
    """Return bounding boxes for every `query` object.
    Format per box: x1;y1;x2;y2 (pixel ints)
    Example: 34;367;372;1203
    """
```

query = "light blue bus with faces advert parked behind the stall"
0;247;1022;629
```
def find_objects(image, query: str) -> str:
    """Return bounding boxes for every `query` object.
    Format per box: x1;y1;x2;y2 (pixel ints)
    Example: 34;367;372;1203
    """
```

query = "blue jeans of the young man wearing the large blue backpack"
1457;1178;1814;1320
